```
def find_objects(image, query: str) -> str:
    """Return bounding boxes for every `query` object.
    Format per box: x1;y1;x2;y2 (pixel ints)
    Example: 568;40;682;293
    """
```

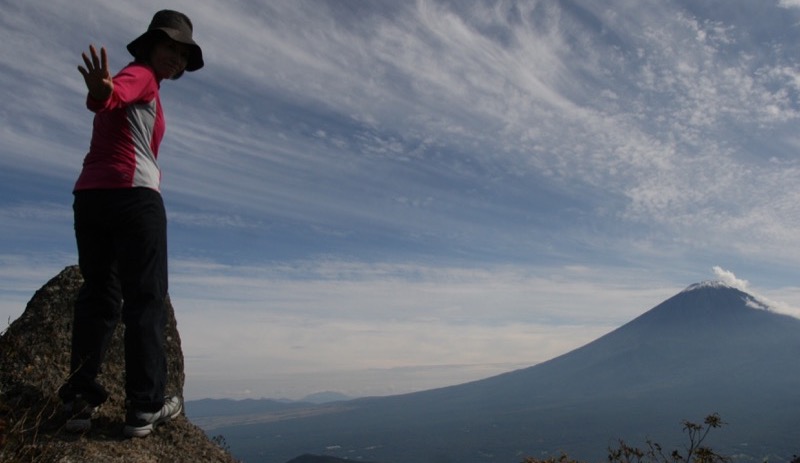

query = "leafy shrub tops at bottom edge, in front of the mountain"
522;413;728;463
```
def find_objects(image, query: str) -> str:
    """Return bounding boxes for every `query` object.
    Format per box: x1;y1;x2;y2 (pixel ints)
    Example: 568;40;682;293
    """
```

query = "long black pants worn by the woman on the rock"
62;188;167;411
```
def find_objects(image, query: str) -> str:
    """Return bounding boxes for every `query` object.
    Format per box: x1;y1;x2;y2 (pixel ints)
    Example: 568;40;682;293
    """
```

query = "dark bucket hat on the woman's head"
128;10;203;72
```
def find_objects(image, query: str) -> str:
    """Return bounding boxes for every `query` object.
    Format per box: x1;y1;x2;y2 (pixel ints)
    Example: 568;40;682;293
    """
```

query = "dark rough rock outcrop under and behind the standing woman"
0;266;235;463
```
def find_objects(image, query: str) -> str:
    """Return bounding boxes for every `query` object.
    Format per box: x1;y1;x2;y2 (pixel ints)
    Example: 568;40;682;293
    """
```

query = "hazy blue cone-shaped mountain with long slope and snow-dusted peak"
205;282;800;463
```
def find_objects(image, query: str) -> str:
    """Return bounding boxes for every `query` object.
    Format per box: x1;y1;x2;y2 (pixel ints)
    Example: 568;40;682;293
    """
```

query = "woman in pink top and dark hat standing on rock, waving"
59;10;203;437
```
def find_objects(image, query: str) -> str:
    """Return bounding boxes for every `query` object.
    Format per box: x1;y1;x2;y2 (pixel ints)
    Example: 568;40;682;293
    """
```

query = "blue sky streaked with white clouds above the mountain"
0;0;800;399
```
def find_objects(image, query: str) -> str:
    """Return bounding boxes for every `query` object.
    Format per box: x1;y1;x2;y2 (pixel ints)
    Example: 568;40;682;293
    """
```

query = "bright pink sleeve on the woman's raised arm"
86;63;158;113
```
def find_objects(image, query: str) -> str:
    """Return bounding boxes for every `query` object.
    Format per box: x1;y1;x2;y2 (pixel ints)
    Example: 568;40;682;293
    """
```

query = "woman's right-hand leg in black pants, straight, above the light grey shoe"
117;188;167;412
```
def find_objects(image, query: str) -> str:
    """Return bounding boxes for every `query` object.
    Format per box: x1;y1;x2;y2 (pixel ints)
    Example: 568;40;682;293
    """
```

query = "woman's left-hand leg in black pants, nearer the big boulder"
59;191;122;406
